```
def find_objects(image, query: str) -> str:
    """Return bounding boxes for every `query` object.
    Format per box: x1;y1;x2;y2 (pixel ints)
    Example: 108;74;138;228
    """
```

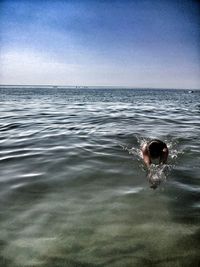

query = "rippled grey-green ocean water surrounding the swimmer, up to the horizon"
0;87;200;267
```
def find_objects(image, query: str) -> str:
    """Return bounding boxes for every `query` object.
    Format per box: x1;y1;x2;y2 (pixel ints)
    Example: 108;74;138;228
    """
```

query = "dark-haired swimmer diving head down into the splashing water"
142;139;169;168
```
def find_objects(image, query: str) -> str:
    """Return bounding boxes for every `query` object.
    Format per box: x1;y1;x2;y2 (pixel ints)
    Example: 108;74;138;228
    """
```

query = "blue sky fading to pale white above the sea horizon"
0;0;200;89
